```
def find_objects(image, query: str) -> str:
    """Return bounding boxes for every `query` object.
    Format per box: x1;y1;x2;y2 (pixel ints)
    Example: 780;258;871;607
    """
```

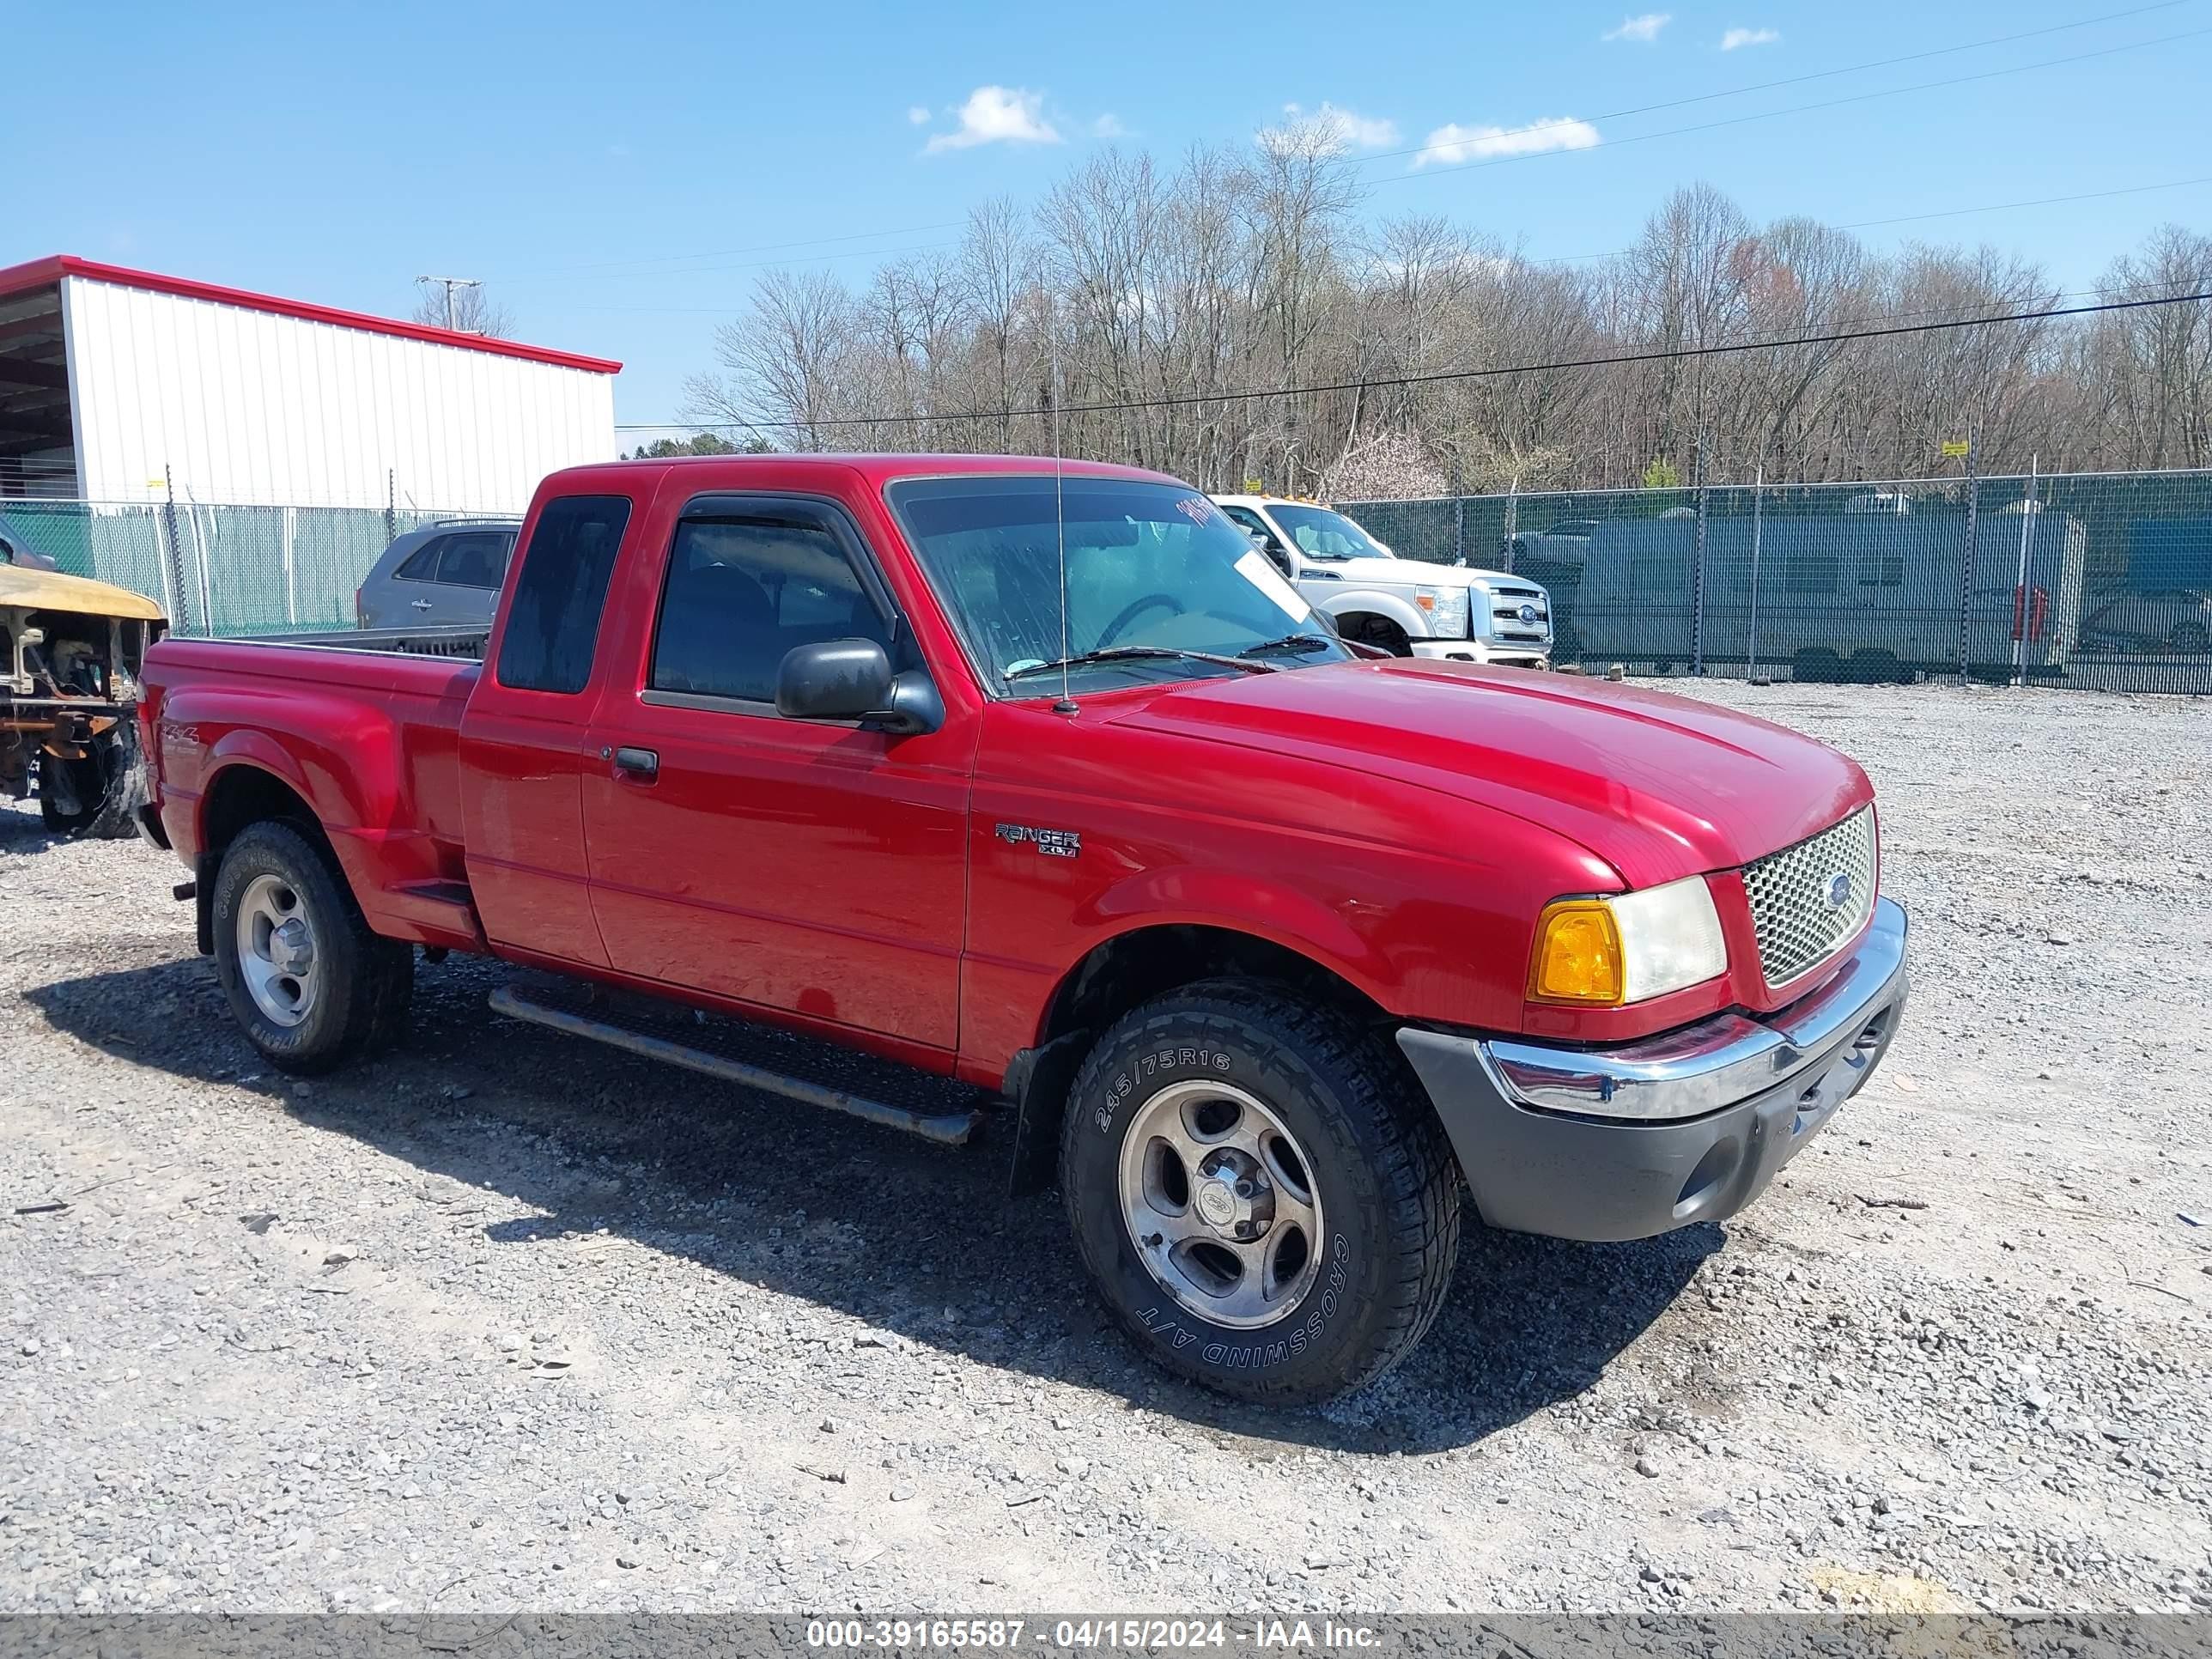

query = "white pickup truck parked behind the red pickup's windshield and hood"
1214;495;1551;668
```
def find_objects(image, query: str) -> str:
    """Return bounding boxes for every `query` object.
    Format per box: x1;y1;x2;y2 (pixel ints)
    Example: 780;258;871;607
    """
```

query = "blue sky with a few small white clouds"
0;0;2212;435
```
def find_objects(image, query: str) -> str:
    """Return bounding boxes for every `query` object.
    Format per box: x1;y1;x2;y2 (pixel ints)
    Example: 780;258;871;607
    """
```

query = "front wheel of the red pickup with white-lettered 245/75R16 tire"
1060;980;1460;1405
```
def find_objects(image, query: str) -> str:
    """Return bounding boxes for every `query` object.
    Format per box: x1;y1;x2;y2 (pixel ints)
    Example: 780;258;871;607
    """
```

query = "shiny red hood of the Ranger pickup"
1119;659;1874;887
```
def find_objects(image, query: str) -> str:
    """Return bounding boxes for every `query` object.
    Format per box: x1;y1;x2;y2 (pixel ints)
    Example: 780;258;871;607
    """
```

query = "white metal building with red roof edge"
0;254;622;514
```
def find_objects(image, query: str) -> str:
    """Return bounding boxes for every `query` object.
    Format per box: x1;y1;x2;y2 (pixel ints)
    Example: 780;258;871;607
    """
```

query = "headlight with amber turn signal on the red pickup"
1528;876;1728;1009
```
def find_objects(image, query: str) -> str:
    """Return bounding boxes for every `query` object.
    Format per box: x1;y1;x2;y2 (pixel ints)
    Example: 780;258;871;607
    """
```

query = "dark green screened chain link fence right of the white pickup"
1338;471;2212;695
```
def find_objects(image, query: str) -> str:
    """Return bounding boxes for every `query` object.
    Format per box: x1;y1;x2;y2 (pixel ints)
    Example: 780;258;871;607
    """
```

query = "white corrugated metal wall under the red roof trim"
64;276;617;514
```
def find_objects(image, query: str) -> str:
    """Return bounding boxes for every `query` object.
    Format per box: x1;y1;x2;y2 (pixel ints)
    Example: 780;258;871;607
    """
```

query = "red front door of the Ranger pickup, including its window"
584;493;975;1048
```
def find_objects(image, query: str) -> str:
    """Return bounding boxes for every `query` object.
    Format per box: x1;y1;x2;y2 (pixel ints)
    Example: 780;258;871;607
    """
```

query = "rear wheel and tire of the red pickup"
215;818;414;1078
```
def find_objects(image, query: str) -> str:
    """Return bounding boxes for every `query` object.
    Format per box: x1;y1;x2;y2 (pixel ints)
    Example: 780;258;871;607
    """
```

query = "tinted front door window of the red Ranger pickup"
648;508;891;703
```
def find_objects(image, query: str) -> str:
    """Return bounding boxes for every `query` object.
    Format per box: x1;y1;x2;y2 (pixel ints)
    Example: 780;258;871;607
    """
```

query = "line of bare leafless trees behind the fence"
688;150;2212;495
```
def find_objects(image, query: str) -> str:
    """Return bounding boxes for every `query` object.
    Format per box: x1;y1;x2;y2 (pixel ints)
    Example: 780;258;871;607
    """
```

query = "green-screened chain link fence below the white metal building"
0;500;501;635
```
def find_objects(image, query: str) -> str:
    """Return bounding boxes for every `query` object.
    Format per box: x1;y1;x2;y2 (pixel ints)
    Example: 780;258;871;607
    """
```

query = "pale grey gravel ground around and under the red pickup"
0;686;2212;1613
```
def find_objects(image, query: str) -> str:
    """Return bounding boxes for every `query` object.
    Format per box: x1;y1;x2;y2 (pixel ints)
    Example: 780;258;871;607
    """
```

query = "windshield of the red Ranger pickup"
887;476;1352;696
